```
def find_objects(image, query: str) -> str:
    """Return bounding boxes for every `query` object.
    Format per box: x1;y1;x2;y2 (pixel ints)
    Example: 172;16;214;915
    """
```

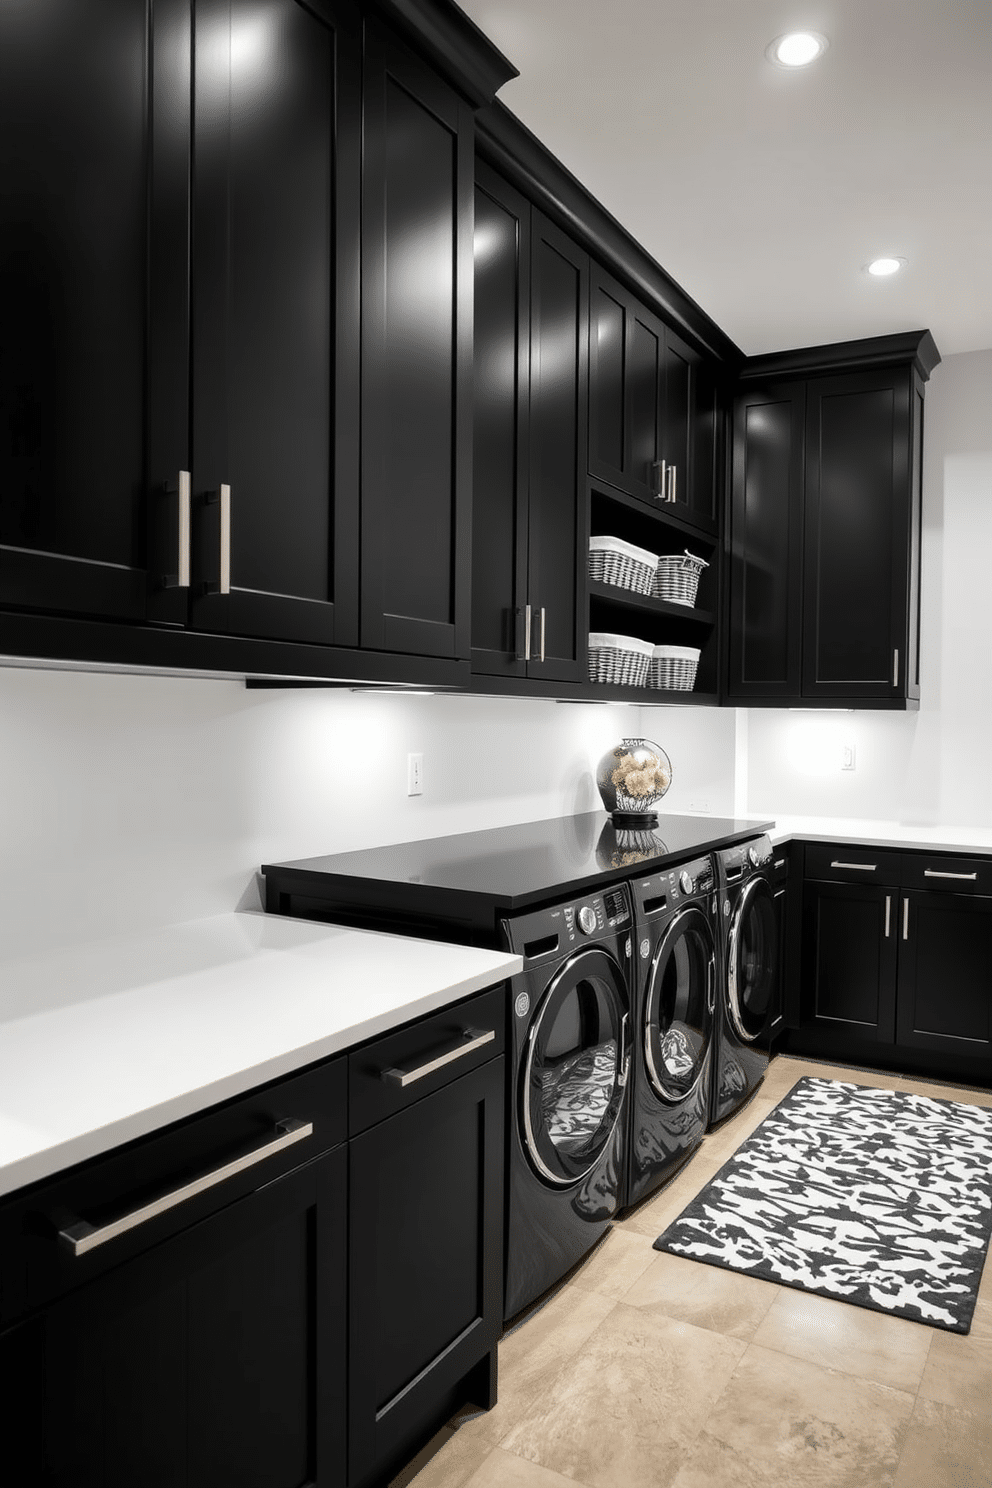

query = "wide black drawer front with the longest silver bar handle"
0;1058;348;1323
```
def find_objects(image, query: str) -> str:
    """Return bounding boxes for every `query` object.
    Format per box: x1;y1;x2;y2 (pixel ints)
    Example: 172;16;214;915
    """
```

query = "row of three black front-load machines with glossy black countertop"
265;814;778;1318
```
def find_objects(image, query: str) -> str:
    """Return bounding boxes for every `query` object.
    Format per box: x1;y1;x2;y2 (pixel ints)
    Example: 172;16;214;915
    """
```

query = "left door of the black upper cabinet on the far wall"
729;382;806;699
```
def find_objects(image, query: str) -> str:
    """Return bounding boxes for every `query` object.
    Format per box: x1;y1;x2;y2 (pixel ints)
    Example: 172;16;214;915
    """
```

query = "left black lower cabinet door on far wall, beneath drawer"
803;882;898;1043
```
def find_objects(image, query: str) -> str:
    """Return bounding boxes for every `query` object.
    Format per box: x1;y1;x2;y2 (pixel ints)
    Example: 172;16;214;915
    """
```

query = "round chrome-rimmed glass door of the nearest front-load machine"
522;949;628;1184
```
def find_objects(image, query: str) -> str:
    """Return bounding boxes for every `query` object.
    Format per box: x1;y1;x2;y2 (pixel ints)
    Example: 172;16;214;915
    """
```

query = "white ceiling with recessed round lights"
461;0;992;356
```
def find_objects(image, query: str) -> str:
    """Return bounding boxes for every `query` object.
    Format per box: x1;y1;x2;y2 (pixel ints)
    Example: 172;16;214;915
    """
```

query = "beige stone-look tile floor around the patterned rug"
394;1058;992;1488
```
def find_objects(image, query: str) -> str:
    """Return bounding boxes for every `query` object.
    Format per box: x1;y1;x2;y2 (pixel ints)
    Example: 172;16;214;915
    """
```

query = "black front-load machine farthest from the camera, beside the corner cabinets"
709;836;779;1125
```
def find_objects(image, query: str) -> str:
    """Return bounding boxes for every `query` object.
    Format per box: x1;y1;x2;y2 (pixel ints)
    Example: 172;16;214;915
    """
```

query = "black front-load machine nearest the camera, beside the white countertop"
504;884;632;1318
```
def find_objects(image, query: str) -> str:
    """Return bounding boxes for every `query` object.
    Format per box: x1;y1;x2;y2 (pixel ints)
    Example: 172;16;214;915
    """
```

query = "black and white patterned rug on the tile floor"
654;1077;992;1333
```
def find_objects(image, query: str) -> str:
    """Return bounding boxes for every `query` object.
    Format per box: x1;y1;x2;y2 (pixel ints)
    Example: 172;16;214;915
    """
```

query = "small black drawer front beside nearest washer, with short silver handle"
348;985;506;1137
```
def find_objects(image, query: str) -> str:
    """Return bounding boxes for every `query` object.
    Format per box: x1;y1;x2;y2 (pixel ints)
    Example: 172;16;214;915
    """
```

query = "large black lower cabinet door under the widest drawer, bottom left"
0;1147;347;1488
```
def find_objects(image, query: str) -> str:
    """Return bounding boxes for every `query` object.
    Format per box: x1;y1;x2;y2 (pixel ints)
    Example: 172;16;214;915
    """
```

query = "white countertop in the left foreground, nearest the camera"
0;912;522;1193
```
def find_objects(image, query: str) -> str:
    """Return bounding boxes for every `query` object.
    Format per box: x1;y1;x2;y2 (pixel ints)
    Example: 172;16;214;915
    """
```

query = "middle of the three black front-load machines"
625;857;718;1204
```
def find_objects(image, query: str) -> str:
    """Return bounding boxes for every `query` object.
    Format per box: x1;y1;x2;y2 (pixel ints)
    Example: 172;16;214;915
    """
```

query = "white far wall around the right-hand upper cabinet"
741;351;992;826
